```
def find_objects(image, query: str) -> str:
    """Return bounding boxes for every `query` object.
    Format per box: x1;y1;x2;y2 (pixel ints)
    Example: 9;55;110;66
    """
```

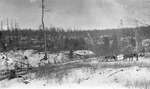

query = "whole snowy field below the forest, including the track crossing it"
0;50;150;89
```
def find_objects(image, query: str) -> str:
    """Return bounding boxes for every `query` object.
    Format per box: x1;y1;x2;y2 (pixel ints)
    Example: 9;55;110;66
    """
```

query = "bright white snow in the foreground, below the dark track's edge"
0;66;150;89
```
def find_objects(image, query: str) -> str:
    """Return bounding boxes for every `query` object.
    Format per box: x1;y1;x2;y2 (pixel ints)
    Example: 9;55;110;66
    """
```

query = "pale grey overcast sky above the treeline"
0;0;150;29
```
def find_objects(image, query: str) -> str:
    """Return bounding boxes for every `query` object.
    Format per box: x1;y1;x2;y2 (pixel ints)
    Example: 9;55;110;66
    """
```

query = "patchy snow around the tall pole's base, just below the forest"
0;50;68;70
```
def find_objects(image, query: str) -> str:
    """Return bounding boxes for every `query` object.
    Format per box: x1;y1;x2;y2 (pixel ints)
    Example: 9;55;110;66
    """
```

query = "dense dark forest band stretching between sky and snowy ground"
0;26;150;55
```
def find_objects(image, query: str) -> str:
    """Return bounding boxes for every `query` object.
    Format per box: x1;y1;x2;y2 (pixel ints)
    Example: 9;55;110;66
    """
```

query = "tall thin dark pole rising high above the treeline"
41;0;47;59
